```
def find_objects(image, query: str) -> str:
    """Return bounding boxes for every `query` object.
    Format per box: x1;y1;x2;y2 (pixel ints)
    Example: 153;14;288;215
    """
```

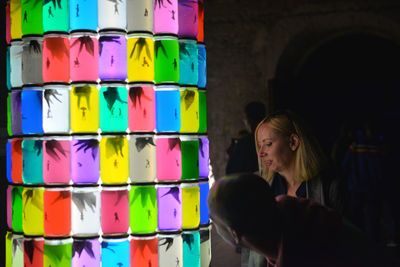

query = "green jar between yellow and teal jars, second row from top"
154;35;179;84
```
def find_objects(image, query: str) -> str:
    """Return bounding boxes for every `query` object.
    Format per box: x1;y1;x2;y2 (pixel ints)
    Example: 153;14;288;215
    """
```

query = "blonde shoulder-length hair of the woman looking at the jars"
255;110;327;182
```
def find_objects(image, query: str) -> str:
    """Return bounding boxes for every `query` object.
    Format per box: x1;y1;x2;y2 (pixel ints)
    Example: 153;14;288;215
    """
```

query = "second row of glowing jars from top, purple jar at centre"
7;34;207;89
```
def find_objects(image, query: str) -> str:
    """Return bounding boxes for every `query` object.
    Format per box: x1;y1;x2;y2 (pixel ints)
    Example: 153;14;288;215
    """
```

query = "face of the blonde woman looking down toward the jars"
257;123;295;174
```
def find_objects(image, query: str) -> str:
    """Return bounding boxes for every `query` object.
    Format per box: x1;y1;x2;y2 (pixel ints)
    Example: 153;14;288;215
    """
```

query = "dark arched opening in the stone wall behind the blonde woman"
274;33;400;153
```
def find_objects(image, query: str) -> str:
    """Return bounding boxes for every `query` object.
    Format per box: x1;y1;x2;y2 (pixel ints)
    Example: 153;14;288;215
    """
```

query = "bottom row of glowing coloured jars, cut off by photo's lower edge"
5;226;211;267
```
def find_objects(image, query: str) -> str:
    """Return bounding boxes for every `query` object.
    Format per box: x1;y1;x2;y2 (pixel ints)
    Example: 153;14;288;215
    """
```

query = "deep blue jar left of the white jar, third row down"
21;86;43;134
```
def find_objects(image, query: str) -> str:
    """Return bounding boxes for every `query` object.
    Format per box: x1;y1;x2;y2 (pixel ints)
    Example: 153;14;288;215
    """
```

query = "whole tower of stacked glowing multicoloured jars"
6;0;211;267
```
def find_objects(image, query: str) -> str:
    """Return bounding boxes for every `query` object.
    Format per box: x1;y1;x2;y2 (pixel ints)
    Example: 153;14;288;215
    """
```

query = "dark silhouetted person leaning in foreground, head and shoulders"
208;174;400;267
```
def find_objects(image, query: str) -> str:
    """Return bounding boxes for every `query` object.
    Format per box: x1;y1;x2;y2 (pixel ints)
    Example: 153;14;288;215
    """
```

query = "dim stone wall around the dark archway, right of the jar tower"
205;0;400;178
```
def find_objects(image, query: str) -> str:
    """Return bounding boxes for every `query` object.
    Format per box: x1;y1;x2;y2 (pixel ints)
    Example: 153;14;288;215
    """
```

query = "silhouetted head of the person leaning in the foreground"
208;173;281;256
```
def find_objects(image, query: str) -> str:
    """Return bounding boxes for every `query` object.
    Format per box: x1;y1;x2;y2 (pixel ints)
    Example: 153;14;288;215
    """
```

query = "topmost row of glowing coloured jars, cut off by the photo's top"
6;0;204;41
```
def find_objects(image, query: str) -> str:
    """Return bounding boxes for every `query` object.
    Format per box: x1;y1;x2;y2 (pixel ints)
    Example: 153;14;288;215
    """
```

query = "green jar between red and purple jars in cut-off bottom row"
43;238;72;267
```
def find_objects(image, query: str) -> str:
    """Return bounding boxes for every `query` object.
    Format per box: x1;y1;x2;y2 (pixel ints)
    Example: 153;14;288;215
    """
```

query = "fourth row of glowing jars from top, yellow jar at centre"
6;135;209;184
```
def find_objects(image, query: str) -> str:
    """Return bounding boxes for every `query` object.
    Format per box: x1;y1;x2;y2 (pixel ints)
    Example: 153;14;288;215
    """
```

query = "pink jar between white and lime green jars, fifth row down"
101;186;129;236
